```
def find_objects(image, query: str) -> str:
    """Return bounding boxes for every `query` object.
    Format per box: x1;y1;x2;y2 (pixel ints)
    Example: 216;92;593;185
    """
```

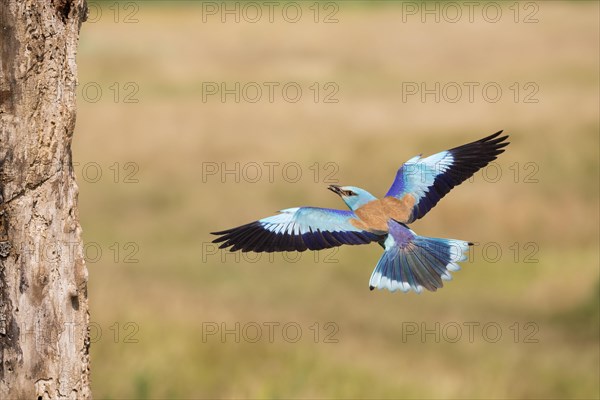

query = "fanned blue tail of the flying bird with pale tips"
369;220;472;293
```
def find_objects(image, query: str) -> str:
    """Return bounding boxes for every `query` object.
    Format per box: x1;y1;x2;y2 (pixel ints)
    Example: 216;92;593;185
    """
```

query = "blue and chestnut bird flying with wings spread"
212;131;509;293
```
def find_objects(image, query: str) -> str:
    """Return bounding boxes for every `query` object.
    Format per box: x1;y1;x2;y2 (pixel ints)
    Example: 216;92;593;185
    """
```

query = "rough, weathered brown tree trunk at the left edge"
0;0;91;399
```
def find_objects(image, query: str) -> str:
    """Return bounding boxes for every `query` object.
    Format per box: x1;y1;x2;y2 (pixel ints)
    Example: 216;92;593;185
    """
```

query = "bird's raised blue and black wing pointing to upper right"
386;131;508;223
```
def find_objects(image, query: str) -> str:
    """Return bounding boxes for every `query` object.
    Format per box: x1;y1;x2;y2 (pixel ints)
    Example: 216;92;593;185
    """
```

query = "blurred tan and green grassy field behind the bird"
73;2;600;399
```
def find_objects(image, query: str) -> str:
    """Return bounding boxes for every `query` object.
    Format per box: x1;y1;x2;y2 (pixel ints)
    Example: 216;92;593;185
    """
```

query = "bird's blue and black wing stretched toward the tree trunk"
213;207;381;253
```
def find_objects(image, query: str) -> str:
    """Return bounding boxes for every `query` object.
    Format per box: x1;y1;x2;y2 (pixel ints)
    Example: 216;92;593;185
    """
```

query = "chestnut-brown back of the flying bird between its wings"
350;194;415;232
